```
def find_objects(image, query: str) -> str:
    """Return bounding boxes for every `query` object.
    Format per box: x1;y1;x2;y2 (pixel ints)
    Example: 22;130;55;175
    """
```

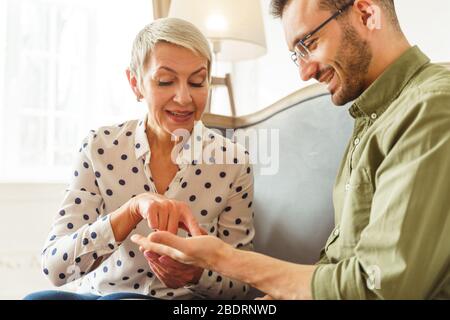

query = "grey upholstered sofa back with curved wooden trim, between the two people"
203;85;353;296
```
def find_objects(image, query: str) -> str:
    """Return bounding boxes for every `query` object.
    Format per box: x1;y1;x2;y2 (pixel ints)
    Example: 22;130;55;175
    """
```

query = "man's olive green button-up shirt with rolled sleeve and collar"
312;47;450;299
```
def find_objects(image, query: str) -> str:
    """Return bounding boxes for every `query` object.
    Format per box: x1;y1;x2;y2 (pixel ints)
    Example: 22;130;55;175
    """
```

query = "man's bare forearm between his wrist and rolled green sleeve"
214;247;316;300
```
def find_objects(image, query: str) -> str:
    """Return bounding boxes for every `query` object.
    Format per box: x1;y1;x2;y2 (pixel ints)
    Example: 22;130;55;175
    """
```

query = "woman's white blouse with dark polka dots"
42;119;254;299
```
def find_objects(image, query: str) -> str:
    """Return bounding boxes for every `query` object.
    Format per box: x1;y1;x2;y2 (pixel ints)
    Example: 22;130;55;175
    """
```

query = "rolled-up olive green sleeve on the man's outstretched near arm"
312;94;450;299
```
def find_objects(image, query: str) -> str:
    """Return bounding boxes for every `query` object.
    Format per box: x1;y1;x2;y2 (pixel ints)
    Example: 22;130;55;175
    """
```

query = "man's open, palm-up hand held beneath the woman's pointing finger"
131;232;229;270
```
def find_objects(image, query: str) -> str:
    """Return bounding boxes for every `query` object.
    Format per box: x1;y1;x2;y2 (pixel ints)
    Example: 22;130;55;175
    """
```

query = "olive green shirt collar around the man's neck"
350;46;430;118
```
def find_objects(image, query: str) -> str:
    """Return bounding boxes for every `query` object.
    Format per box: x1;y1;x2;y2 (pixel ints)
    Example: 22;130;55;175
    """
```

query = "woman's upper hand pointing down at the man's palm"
130;193;202;236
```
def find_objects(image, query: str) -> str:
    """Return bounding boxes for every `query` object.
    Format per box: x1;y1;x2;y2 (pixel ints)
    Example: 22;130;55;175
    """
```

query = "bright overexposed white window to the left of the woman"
0;0;153;182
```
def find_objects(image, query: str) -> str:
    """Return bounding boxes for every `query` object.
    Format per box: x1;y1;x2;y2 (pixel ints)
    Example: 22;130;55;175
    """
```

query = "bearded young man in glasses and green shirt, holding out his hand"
133;0;450;299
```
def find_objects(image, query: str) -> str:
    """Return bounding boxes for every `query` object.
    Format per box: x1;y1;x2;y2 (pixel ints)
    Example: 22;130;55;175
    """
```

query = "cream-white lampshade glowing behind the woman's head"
169;0;266;62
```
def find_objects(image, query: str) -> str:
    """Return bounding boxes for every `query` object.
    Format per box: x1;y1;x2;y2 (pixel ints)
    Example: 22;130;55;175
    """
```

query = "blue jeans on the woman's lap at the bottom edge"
23;290;158;300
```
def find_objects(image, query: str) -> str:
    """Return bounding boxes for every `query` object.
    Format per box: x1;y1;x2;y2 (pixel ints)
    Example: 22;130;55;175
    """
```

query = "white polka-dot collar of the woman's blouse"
134;115;211;166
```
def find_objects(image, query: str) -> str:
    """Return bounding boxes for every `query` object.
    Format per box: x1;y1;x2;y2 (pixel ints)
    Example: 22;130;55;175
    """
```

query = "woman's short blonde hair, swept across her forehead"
130;18;212;86
